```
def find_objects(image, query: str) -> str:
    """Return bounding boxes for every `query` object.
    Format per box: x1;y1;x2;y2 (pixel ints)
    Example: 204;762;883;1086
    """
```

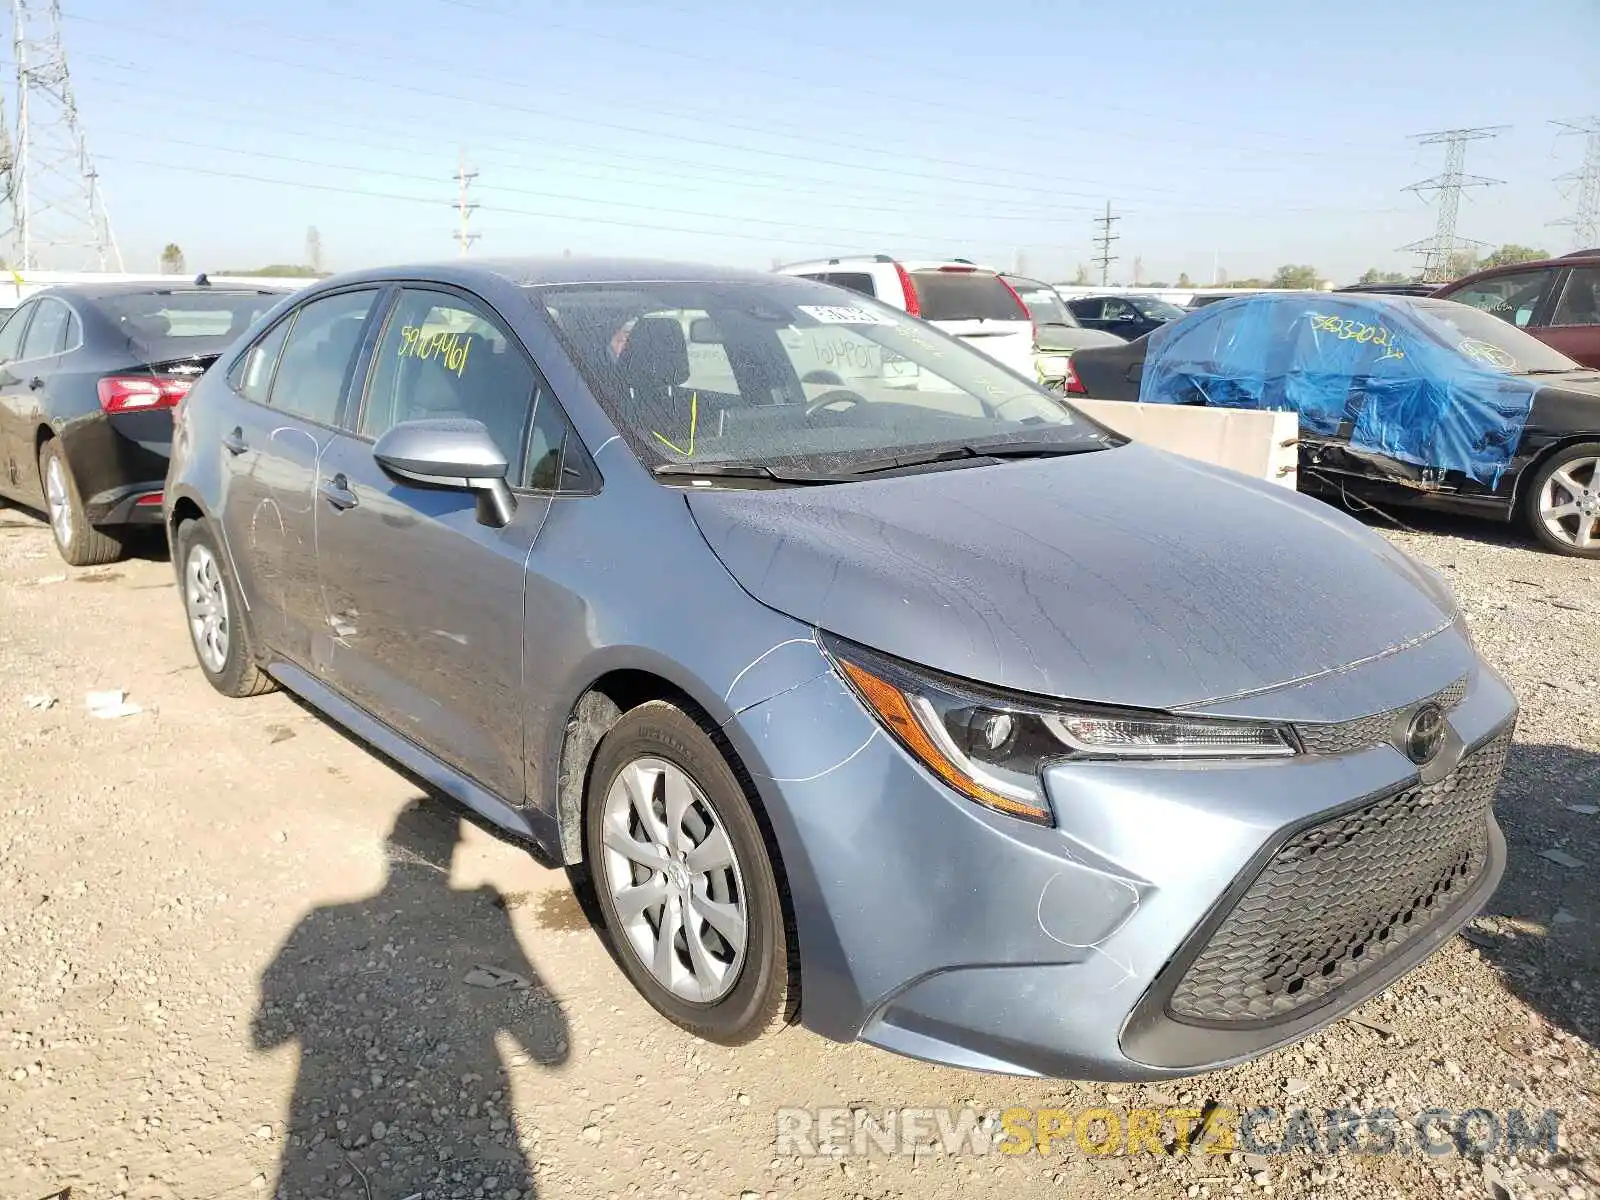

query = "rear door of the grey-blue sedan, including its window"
218;288;379;669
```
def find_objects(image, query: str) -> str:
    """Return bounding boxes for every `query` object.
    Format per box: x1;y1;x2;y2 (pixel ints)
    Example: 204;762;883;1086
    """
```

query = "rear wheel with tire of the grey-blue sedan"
173;520;277;699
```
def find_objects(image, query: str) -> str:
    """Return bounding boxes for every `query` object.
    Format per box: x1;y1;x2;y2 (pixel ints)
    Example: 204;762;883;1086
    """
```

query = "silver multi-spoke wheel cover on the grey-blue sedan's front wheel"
602;757;750;1005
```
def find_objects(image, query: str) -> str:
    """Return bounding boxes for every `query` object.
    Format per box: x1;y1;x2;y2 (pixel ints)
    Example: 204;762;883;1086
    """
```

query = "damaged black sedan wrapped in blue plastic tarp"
1072;293;1600;558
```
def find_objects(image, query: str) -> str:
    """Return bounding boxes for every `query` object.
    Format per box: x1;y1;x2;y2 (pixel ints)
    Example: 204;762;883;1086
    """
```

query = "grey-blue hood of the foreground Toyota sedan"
686;443;1454;709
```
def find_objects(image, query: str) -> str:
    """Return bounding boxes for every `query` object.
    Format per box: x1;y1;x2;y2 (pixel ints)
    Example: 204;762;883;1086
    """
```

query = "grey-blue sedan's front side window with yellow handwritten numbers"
358;288;534;480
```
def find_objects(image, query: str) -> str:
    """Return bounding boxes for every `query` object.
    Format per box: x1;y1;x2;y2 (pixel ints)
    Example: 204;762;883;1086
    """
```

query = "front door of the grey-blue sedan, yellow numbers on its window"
317;288;550;805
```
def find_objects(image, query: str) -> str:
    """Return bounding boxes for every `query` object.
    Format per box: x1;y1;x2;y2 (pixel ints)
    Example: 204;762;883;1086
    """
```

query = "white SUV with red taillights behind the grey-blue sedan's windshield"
778;254;1035;379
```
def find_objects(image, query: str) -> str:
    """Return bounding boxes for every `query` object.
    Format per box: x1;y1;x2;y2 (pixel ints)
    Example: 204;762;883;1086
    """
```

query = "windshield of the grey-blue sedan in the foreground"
530;275;1106;474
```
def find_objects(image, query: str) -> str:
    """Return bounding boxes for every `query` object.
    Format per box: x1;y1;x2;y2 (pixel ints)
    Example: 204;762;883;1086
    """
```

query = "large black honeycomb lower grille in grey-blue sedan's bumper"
1168;733;1510;1022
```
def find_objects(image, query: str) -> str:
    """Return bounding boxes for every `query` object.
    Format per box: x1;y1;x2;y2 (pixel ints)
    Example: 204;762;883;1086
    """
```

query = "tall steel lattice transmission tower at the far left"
3;0;123;270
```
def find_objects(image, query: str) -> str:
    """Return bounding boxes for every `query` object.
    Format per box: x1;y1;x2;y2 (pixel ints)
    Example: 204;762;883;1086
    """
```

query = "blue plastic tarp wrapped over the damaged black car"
1139;293;1538;486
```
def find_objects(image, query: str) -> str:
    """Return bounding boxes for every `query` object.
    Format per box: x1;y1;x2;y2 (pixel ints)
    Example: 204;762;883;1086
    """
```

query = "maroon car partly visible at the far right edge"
1434;246;1600;368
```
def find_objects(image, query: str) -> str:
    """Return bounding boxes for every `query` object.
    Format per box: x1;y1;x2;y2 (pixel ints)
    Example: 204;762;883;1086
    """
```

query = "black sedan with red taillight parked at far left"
0;278;285;566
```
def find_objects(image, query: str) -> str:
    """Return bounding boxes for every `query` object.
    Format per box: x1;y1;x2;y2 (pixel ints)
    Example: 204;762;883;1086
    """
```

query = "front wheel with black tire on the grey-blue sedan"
584;701;798;1045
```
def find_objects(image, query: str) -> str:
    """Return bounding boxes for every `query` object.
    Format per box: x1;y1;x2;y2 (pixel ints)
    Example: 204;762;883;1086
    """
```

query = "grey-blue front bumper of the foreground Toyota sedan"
730;632;1517;1080
